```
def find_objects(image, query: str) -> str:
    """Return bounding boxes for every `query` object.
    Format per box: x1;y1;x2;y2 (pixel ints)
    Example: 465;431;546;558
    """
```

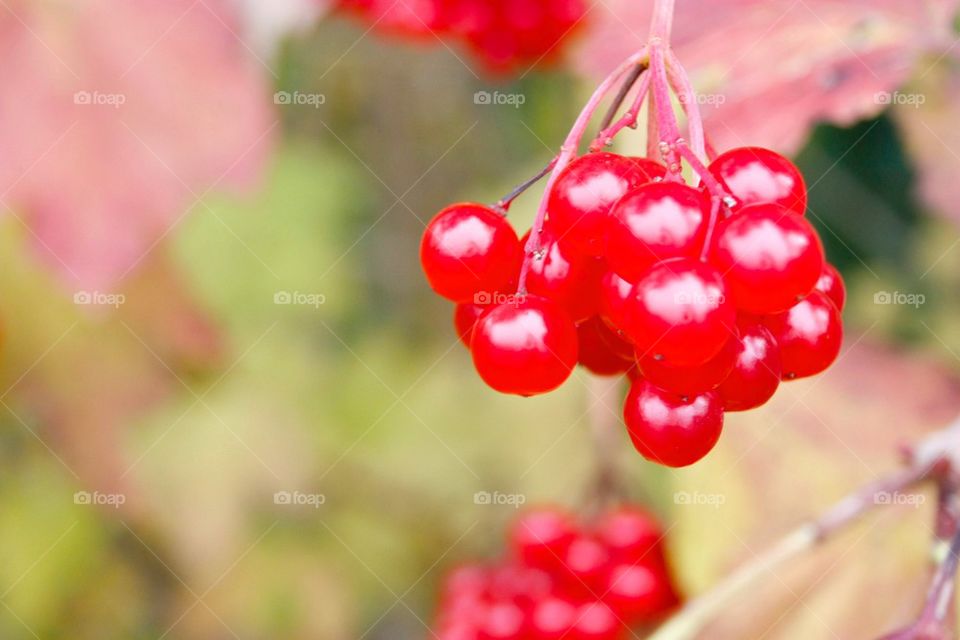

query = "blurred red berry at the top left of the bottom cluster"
510;507;577;569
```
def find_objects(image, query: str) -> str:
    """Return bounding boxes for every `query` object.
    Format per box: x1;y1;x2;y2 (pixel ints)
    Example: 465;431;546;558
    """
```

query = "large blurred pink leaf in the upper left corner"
0;0;274;287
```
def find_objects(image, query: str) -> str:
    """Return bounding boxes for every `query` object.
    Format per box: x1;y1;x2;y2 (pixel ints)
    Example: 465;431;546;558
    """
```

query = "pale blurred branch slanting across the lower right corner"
648;418;960;640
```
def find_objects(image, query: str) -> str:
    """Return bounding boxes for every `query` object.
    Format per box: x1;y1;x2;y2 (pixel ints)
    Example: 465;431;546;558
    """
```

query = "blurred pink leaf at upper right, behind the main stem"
577;0;958;152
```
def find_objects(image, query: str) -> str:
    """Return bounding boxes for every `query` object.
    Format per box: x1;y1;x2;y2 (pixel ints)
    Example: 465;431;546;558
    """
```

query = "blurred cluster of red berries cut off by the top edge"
339;0;586;72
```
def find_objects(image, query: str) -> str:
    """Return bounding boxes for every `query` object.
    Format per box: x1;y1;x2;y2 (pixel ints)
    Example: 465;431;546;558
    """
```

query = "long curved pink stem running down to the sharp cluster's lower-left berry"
517;47;647;295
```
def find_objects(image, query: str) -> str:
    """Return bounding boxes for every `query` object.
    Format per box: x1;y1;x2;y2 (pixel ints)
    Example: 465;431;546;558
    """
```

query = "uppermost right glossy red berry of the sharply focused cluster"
710;147;807;215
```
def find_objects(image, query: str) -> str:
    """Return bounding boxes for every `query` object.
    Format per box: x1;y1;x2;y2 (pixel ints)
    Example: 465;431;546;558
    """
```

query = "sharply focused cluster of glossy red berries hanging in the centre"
420;147;846;466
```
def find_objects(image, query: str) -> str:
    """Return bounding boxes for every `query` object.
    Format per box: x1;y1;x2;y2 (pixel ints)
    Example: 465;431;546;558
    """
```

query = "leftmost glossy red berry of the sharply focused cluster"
420;203;523;302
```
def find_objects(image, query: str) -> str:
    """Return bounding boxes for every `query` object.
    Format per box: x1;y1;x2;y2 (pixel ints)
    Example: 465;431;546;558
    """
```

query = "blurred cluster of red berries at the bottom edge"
434;507;677;640
